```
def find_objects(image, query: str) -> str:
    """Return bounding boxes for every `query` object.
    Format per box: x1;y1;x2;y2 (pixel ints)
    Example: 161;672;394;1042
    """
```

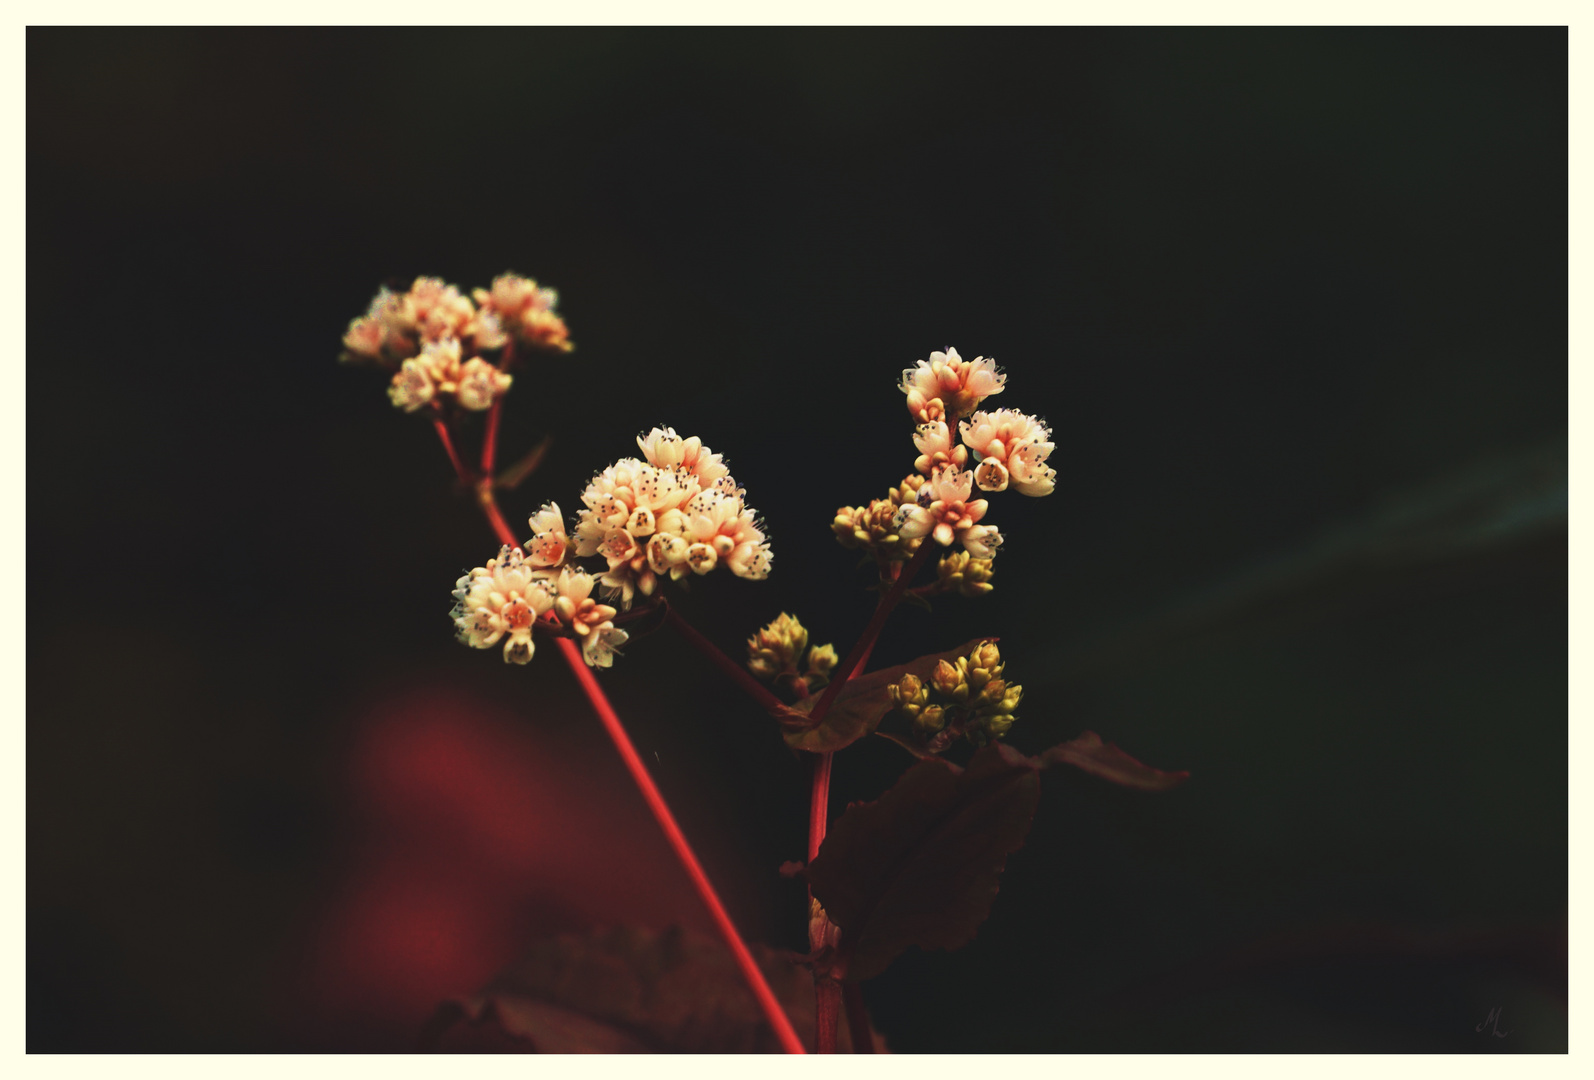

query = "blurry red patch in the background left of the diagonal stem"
295;687;709;1048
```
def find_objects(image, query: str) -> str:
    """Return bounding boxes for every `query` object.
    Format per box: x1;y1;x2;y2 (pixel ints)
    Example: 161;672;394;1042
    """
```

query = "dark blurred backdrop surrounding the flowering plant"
27;29;1567;1053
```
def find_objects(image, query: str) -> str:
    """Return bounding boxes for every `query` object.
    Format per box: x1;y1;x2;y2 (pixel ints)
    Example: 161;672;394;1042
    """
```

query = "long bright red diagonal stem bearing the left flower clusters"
437;419;807;1055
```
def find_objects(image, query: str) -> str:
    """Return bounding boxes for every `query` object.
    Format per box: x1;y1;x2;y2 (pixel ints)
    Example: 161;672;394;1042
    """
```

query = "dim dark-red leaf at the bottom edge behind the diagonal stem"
424;927;881;1053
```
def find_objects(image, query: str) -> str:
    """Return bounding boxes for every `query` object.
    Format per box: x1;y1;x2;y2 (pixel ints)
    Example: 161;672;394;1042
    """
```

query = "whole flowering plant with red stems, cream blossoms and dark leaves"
344;274;1186;1053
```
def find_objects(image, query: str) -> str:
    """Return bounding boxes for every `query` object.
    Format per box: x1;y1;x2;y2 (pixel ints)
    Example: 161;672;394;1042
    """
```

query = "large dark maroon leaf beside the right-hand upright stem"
808;745;1041;980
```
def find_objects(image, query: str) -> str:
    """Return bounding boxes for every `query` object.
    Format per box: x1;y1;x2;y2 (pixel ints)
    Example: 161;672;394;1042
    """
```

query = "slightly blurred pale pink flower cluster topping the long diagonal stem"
343;274;572;413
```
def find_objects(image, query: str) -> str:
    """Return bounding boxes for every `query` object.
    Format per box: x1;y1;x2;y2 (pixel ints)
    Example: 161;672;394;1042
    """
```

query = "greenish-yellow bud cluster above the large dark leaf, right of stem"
889;642;1023;753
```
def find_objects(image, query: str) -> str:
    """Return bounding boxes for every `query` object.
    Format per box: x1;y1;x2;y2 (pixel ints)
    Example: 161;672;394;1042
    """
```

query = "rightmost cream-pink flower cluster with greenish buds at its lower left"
830;349;1057;579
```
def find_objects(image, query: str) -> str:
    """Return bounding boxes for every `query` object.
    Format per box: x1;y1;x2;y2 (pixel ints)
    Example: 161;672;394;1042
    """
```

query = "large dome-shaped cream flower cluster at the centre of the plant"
574;427;771;618
